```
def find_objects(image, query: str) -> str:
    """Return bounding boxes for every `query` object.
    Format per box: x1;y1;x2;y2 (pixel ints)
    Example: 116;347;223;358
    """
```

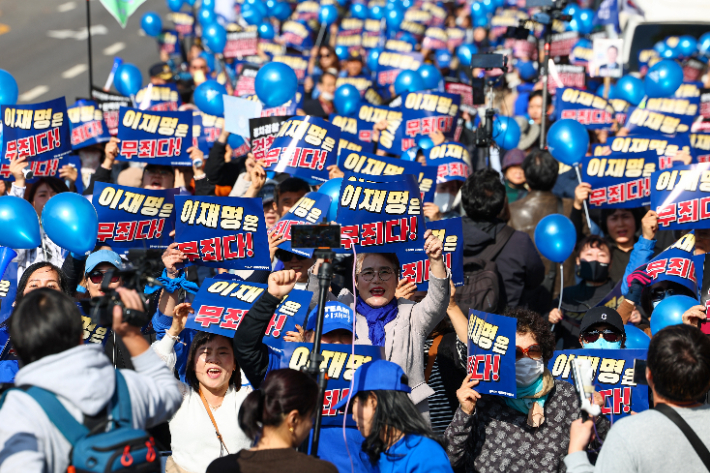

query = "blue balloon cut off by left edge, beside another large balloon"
0;195;40;250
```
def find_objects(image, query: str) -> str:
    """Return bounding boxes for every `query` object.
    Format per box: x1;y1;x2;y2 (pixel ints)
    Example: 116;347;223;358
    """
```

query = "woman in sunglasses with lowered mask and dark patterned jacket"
444;308;609;473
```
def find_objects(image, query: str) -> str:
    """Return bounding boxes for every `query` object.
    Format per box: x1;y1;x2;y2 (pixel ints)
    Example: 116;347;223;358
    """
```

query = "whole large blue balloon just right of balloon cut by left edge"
42;192;99;254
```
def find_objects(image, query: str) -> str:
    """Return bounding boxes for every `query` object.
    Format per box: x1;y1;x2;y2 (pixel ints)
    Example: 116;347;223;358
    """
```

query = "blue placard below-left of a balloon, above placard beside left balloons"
116;107;193;166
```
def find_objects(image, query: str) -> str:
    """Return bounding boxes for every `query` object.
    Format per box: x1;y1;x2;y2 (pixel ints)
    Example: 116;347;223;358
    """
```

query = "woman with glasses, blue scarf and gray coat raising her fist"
308;230;451;420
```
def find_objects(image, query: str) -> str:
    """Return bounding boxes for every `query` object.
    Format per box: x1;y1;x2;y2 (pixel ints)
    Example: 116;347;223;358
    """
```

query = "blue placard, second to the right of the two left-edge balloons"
175;195;271;271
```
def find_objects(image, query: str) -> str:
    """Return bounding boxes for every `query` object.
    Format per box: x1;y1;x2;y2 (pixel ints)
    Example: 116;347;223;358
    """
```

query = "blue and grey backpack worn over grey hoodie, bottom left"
0;370;161;473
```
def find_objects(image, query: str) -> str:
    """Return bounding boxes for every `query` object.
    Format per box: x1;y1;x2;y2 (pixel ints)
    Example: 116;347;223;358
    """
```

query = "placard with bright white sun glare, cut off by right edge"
651;163;710;230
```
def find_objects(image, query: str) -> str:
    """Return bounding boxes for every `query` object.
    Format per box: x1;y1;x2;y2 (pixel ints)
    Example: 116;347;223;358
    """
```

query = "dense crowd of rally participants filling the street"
0;0;710;473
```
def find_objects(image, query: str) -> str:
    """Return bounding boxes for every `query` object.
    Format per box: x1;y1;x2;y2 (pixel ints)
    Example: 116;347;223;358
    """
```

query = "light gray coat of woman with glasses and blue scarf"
307;269;451;416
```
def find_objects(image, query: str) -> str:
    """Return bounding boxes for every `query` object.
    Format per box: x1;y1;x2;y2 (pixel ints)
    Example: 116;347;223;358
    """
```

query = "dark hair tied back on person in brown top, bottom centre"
238;368;318;440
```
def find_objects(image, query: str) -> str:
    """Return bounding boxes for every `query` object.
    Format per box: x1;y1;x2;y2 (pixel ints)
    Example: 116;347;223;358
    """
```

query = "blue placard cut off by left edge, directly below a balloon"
0;97;72;163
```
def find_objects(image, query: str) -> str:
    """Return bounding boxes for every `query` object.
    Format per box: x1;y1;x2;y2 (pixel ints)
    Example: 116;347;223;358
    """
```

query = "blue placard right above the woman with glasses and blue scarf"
336;174;426;253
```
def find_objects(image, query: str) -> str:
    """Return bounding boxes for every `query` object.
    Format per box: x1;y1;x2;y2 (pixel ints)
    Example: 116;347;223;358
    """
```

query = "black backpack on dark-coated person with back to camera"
454;225;515;316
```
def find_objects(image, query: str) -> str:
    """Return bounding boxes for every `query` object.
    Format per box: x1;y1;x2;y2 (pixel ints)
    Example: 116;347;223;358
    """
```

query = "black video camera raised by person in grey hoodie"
89;250;162;327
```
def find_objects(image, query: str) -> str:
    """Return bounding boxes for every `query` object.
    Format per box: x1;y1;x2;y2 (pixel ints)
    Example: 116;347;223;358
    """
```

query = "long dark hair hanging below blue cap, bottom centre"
357;391;443;465
